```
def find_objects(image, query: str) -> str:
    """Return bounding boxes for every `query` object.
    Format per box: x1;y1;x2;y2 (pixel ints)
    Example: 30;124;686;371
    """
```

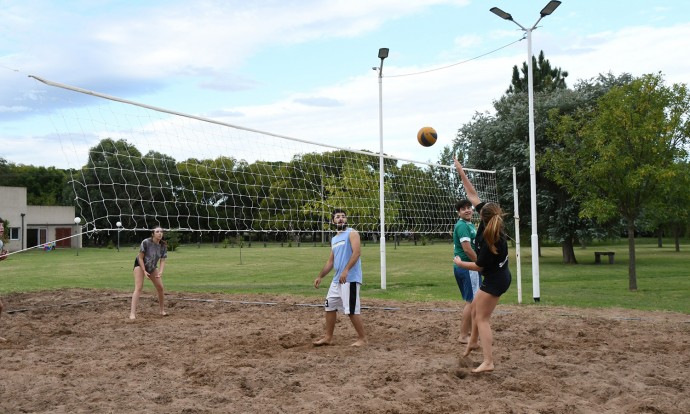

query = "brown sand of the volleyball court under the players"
0;290;690;414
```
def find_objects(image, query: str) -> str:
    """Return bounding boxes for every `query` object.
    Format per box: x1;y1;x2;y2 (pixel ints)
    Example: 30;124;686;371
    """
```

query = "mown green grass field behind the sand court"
0;239;690;314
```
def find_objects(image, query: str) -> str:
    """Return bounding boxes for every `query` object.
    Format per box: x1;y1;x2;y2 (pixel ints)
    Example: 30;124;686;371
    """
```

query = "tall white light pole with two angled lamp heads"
490;0;561;302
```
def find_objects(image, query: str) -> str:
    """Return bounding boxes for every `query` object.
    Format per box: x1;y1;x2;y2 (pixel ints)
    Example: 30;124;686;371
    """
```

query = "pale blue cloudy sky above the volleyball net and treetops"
0;0;690;168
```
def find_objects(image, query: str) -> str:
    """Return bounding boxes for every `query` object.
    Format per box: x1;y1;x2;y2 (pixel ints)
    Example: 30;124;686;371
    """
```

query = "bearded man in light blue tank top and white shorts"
314;209;367;346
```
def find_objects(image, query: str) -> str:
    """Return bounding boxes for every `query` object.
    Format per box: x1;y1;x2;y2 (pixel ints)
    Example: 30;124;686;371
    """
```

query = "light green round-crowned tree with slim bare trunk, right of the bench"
548;74;690;291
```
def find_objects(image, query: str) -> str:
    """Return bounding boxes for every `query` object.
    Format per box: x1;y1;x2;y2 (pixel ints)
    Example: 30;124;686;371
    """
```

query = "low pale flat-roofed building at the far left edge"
0;186;81;252
